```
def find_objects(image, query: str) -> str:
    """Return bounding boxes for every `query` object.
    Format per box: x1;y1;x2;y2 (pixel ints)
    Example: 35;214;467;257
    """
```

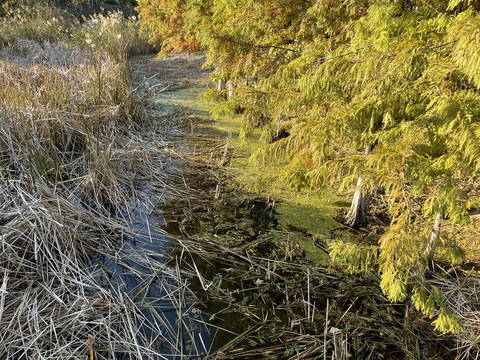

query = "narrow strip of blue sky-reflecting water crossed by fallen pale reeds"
93;198;212;359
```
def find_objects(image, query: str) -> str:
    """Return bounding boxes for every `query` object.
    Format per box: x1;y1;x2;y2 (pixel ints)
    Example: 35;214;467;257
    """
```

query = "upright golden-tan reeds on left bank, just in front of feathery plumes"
0;53;143;132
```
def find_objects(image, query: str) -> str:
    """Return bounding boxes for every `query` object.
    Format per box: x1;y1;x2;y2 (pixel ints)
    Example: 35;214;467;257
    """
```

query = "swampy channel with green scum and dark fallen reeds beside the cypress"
123;54;468;359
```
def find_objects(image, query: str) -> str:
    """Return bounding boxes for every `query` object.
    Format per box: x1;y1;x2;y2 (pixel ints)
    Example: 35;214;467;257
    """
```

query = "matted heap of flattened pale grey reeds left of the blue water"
0;181;153;359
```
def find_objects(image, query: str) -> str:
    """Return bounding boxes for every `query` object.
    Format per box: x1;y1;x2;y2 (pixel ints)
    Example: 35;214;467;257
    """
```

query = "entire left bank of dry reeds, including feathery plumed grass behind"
0;1;182;359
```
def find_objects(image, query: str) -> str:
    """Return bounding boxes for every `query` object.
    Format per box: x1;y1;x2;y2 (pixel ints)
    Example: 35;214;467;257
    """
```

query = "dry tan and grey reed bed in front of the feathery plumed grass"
0;47;199;360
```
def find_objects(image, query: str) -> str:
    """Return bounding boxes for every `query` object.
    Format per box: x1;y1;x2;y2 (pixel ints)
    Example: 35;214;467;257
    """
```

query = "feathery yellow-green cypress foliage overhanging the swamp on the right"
137;0;480;332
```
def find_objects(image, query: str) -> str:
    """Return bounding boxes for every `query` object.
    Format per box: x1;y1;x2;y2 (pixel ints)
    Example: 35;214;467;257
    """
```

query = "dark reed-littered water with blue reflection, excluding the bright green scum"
94;56;458;359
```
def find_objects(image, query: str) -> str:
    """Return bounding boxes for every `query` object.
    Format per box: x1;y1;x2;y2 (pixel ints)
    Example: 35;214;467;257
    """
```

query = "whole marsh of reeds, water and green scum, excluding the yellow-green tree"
0;8;480;360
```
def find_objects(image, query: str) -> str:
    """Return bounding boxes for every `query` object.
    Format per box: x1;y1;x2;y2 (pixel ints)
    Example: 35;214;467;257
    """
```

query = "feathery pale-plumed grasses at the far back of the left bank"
0;1;158;63
